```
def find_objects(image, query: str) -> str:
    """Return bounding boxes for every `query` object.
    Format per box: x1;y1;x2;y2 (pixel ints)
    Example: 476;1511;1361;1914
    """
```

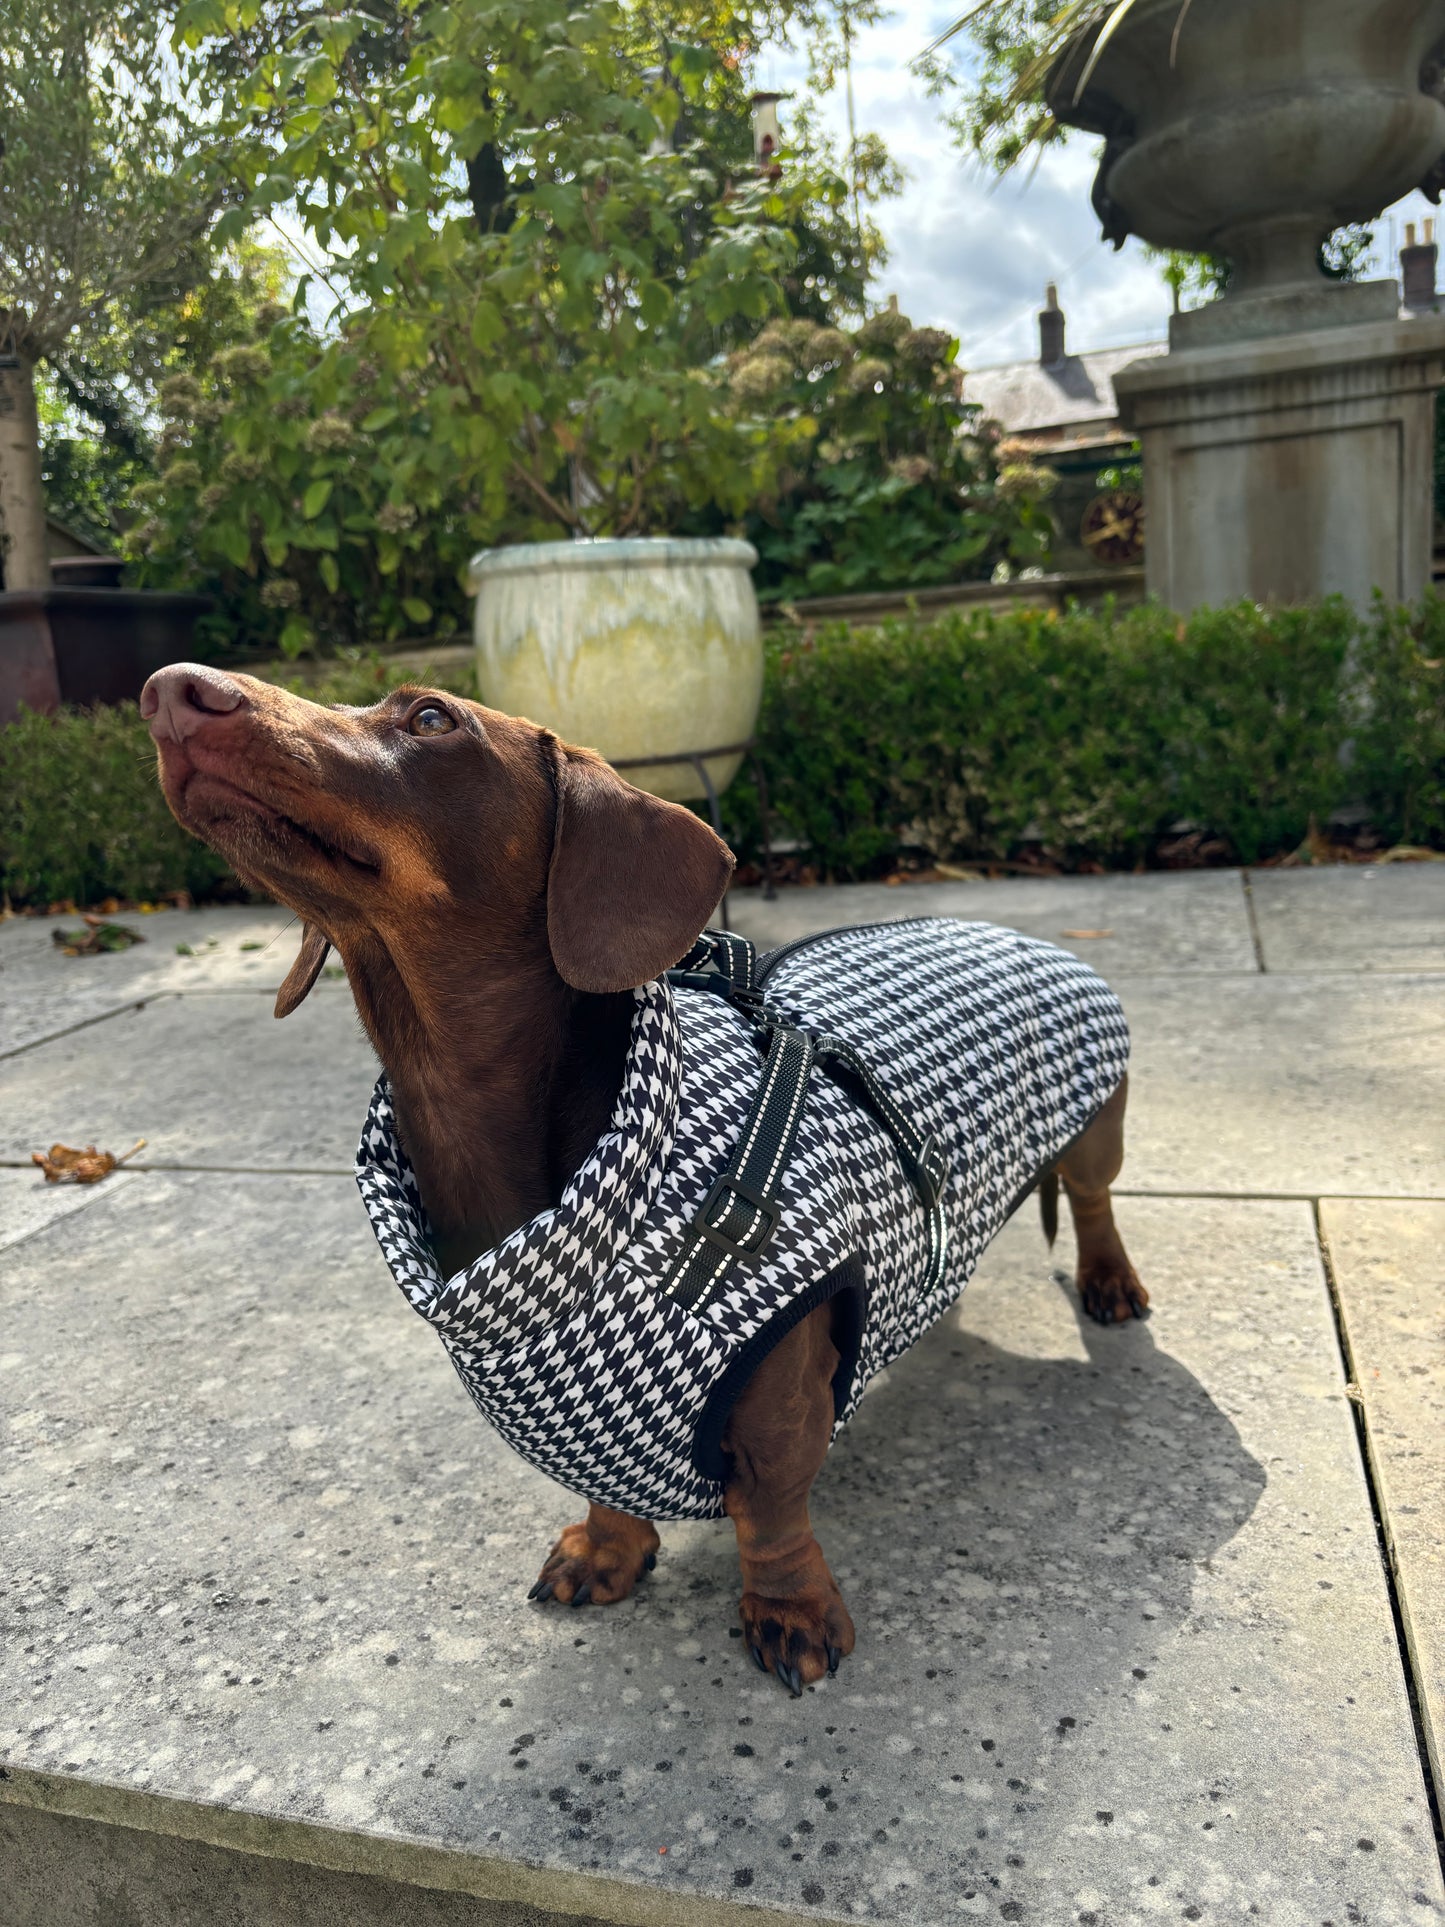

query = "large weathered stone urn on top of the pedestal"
1048;0;1445;347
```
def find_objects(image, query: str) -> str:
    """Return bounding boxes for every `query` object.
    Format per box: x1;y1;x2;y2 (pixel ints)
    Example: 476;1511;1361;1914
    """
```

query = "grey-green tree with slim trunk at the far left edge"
0;0;223;590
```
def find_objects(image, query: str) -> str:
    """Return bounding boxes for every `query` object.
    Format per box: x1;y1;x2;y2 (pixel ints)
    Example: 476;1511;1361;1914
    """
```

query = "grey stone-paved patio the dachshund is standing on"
0;863;1445;1927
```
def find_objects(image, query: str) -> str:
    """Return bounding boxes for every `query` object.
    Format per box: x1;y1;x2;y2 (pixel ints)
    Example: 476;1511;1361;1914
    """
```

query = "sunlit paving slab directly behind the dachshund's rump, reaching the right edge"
1112;975;1445;1197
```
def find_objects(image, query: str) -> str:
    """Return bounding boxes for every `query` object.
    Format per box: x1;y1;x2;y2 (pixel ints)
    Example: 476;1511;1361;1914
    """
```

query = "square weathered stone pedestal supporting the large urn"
1114;316;1445;613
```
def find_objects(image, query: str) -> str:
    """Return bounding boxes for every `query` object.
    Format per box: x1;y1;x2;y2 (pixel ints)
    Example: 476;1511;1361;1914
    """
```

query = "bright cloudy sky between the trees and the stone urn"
759;0;1445;368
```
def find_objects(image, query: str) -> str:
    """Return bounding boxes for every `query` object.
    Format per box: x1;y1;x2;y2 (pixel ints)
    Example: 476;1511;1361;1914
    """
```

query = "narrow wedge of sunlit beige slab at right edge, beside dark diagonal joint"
1320;1199;1445;1808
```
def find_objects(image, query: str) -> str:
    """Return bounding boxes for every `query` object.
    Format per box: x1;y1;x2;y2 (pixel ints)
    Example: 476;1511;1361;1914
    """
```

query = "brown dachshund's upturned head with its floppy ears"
141;663;732;1016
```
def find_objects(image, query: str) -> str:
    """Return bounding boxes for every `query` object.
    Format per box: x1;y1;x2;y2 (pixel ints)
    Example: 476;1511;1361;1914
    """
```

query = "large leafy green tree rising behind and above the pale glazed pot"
135;0;905;651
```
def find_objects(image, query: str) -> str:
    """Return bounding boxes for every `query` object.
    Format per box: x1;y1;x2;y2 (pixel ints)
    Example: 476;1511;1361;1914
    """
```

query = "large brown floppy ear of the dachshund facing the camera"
547;742;732;990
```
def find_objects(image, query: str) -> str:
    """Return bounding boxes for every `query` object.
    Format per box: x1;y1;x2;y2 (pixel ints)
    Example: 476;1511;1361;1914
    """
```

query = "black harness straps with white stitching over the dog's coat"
663;931;948;1308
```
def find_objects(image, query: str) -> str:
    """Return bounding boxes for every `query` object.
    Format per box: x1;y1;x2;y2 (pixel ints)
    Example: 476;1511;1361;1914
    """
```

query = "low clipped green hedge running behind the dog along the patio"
0;595;1445;906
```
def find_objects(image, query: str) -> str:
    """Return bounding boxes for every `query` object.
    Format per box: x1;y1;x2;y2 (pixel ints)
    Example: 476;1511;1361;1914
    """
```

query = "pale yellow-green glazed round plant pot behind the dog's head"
470;536;763;802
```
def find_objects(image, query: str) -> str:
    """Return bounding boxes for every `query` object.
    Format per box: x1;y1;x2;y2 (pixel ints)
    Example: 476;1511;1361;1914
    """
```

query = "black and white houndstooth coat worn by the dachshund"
356;919;1129;1518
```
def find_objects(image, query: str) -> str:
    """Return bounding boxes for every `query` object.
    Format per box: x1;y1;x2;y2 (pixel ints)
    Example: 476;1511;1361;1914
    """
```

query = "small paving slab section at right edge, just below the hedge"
1248;863;1445;973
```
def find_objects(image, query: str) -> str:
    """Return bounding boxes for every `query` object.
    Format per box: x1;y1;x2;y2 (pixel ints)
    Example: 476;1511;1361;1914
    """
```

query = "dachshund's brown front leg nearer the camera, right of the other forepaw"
723;1305;854;1696
